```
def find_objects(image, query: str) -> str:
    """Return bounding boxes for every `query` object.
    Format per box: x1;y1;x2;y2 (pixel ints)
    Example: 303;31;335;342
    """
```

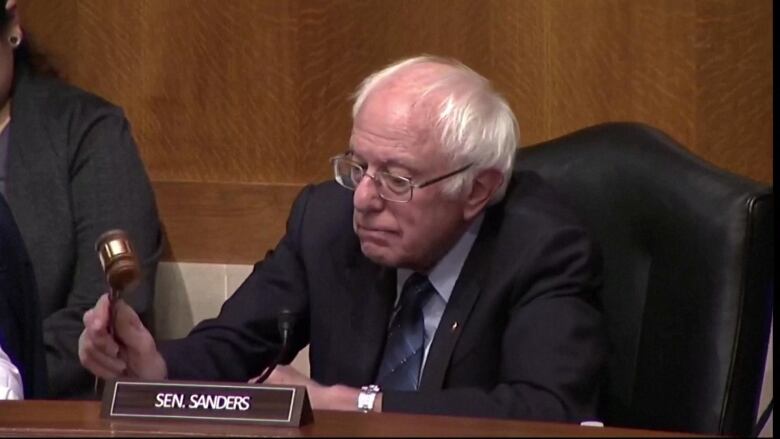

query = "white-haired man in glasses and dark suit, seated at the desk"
80;57;606;422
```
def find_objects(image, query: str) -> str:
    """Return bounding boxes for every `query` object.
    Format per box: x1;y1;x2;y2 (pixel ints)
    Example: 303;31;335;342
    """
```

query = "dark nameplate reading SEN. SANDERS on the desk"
100;379;313;427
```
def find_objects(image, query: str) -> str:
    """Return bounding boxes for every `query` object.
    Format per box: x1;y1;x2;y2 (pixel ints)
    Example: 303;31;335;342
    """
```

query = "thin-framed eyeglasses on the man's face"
330;154;471;203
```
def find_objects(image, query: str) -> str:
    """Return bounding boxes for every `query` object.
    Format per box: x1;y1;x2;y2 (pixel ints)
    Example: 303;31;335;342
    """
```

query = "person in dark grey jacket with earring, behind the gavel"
0;0;162;398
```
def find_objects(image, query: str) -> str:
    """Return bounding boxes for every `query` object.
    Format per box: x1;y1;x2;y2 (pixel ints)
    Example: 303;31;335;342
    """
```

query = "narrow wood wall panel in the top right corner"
693;0;774;182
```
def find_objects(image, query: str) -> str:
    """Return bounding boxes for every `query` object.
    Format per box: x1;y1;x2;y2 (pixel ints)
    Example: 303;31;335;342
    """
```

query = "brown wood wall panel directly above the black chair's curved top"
545;0;696;145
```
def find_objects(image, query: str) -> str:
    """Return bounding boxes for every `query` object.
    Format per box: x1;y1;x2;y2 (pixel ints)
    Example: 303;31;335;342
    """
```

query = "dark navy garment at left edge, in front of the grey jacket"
0;195;48;399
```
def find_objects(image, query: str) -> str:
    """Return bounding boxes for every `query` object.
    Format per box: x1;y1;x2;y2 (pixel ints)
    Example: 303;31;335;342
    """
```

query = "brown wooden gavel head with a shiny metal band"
95;229;141;293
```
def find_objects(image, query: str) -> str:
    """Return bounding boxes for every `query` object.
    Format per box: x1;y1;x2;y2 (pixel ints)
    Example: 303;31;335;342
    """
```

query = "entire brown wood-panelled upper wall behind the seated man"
19;0;773;259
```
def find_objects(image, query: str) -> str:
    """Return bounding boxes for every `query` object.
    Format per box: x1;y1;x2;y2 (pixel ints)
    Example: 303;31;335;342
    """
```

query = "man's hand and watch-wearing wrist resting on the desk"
256;366;382;412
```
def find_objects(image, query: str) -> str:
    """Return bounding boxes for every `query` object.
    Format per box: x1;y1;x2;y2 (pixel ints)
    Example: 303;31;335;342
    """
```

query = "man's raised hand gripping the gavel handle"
79;294;167;380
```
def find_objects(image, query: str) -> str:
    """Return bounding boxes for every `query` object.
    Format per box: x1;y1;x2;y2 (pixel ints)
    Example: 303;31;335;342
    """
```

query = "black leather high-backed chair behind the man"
517;123;774;435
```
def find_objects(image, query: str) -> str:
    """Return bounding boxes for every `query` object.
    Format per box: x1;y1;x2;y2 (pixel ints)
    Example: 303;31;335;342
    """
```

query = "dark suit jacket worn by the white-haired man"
161;172;606;421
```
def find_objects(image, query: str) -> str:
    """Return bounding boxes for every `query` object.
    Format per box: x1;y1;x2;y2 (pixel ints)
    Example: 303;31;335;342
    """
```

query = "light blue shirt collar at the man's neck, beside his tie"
396;212;485;302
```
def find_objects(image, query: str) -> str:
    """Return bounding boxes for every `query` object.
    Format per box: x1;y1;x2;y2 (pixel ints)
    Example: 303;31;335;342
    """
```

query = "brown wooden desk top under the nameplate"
0;400;700;437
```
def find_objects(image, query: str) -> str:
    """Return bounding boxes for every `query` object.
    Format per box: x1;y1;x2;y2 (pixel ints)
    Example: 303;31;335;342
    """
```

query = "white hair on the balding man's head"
352;55;520;204
